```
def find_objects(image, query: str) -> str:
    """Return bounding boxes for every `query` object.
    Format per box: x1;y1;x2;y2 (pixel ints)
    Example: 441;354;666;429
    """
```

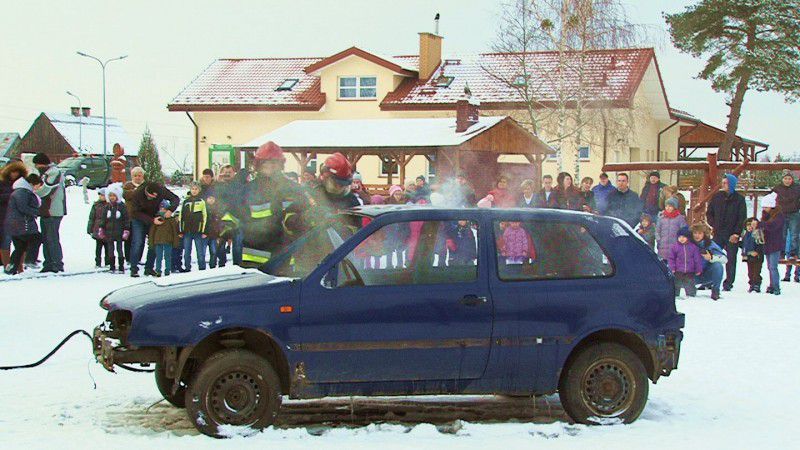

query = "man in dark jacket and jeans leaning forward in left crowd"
129;182;181;278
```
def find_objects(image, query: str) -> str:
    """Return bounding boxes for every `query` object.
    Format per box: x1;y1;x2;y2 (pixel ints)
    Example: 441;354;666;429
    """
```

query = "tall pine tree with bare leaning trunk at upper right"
664;0;800;160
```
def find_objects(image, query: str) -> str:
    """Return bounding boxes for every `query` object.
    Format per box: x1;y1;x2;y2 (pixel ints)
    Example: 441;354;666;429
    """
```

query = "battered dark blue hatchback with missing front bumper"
94;206;684;436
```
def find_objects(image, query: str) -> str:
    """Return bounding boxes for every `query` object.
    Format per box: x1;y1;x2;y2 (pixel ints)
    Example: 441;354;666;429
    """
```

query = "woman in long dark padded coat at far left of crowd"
3;173;43;275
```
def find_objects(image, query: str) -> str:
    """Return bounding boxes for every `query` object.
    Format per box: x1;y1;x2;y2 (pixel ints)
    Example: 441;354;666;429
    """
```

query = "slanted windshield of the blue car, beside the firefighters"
261;214;364;278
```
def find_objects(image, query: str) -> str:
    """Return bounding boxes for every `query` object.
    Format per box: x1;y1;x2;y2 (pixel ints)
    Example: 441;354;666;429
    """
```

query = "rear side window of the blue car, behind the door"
494;221;614;281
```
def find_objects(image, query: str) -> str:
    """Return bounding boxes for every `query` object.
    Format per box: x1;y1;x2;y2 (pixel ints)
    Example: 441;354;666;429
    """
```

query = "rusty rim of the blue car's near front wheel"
209;370;268;426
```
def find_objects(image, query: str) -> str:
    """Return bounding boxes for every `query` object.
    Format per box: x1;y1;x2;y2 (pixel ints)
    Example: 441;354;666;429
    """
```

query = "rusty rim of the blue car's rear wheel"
581;358;636;417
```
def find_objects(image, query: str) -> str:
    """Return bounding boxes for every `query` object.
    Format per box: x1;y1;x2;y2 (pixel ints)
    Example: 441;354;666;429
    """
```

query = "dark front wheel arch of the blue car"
177;327;291;394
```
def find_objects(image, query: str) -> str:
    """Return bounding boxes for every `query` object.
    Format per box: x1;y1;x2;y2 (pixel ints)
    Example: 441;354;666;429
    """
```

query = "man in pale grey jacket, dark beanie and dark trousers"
27;153;67;273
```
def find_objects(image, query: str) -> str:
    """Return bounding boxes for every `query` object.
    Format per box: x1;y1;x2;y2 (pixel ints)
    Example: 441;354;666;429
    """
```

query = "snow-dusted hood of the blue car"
102;266;294;312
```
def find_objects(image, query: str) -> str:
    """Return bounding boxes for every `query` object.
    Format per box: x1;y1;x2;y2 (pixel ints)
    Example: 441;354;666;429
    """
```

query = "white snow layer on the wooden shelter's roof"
241;116;507;148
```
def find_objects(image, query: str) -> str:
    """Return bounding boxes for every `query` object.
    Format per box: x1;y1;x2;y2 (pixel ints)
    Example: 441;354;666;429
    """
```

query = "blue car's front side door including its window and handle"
297;214;492;383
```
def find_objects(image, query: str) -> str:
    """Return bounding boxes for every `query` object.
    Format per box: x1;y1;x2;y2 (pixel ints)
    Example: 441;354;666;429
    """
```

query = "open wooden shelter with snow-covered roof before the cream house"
238;116;554;193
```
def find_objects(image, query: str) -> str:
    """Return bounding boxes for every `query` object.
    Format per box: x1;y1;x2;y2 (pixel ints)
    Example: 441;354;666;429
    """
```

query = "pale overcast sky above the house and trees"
0;0;800;168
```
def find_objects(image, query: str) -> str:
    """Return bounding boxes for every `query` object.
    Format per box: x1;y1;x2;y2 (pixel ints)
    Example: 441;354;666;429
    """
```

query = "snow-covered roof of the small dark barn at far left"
44;113;139;156
